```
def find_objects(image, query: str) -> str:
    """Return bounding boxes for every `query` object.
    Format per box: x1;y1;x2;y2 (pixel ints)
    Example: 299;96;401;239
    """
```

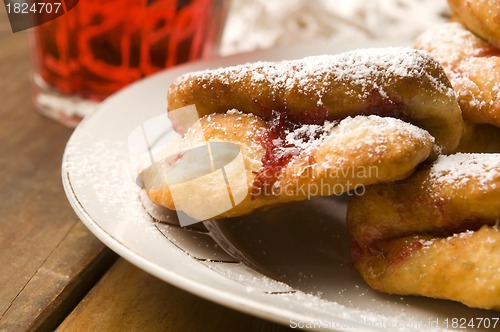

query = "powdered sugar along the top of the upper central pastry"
177;47;453;100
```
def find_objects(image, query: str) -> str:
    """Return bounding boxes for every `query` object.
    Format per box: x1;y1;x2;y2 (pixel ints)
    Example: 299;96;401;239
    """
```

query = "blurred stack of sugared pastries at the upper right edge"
415;0;500;152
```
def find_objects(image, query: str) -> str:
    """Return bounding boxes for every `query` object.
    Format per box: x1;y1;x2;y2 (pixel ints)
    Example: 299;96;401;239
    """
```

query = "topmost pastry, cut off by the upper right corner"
448;0;500;48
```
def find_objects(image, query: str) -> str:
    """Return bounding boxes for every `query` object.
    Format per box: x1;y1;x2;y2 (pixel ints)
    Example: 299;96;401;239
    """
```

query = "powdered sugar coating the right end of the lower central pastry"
277;115;435;189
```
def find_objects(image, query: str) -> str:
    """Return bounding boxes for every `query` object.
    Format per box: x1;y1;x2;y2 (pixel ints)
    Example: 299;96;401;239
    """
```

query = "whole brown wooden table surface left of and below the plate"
0;10;288;331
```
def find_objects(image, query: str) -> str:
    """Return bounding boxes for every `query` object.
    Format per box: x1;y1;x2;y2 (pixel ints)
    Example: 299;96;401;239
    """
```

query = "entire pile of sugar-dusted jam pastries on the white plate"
145;0;500;310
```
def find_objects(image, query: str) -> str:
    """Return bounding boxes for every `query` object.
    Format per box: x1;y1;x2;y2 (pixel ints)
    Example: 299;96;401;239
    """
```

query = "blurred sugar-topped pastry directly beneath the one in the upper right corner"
415;22;500;127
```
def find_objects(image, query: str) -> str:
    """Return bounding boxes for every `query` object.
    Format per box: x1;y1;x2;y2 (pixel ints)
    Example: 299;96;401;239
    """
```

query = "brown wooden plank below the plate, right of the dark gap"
57;259;288;332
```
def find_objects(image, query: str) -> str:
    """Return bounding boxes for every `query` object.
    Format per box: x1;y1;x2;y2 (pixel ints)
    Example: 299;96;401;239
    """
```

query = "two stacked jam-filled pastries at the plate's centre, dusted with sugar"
148;48;463;219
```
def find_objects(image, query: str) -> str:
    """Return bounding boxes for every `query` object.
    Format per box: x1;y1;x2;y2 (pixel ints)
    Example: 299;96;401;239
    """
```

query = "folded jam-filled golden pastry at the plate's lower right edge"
347;153;500;310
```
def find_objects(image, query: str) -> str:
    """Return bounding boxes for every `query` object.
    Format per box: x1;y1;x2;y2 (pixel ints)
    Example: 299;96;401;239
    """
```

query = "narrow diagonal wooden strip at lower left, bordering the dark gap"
0;222;115;331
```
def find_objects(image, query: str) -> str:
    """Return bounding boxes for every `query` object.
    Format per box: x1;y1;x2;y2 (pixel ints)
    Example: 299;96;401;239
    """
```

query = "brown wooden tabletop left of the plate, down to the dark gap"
0;10;116;331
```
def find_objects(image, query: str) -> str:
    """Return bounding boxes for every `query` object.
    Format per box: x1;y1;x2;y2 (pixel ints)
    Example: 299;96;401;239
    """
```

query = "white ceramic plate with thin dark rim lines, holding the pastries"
62;41;500;331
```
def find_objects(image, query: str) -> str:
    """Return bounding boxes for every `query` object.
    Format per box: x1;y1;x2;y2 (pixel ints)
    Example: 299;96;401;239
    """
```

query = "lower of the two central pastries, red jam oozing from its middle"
146;110;434;219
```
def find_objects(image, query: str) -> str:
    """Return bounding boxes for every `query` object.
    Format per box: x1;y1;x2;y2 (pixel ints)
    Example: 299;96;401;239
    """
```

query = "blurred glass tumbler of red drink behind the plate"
30;0;228;127
